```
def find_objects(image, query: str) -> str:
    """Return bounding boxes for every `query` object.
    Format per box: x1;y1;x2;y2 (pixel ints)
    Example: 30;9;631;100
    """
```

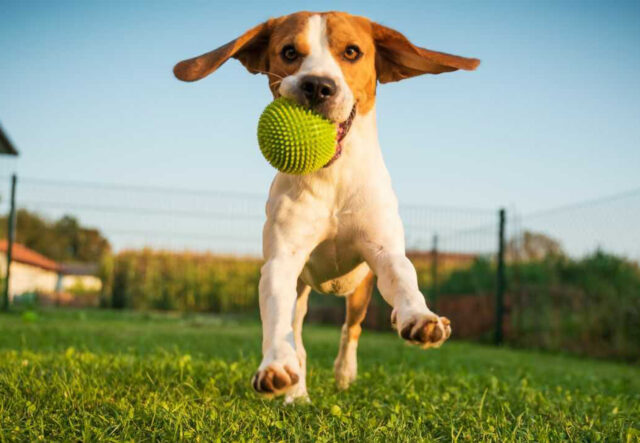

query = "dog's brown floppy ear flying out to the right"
371;23;480;83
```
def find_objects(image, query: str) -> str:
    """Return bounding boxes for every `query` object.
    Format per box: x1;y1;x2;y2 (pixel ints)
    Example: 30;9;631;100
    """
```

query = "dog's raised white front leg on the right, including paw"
365;242;451;348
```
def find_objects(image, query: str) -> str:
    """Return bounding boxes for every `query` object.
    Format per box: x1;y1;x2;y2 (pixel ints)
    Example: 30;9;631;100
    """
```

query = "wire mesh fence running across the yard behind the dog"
0;177;640;359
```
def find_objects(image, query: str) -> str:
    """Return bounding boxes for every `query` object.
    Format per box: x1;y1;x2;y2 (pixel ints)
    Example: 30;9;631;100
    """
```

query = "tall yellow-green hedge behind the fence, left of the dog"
101;249;260;312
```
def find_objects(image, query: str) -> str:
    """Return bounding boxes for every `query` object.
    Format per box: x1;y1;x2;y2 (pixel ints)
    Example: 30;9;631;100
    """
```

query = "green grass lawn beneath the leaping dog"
0;312;640;442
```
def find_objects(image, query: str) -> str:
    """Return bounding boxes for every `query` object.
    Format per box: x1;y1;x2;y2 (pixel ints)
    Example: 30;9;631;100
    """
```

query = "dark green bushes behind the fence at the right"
438;251;640;360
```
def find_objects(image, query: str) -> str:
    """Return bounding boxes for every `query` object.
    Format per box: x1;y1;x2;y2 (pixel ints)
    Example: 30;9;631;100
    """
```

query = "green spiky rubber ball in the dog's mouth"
258;98;336;174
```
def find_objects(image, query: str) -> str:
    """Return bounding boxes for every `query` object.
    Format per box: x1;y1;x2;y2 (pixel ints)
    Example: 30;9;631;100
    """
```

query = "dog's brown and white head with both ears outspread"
173;12;480;154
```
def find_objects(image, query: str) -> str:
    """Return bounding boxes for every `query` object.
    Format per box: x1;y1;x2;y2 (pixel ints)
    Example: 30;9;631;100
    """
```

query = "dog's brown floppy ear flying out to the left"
173;20;273;82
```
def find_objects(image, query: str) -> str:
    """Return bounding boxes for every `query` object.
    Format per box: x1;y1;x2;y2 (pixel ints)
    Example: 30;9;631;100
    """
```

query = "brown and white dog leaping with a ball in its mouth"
174;12;480;403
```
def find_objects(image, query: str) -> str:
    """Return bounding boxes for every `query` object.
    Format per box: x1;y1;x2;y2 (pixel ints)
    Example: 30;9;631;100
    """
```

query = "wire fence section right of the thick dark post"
504;189;640;361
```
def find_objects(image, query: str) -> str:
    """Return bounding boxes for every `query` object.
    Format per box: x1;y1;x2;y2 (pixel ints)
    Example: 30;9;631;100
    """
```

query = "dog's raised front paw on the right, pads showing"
391;309;451;349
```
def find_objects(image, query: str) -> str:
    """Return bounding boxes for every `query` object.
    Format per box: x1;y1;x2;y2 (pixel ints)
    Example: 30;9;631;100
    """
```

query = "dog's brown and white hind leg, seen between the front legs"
333;272;375;389
